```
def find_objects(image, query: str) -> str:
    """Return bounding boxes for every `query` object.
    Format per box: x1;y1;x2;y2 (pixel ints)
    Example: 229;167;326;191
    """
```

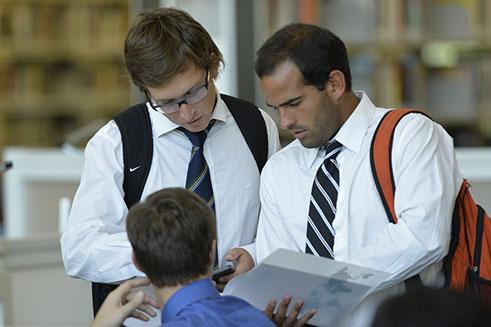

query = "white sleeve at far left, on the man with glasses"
61;121;142;282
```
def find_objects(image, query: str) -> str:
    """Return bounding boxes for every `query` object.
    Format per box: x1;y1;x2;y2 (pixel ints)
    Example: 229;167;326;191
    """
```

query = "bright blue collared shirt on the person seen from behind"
161;278;274;326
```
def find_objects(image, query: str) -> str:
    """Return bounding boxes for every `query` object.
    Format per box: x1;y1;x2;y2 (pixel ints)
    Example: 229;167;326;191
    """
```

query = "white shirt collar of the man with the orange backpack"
305;91;375;167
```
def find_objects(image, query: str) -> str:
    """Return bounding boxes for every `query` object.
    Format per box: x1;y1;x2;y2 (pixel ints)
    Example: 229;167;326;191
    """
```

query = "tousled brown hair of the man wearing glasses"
124;8;223;92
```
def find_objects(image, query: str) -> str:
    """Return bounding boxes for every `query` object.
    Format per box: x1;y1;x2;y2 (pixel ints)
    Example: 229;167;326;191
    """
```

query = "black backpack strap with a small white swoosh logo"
114;103;153;209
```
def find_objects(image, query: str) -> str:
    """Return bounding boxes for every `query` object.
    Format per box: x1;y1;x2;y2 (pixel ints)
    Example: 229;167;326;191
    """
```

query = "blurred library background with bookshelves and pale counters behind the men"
0;0;491;325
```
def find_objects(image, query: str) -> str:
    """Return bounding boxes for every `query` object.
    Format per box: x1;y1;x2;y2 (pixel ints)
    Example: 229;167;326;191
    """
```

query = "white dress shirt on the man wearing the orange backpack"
256;92;462;325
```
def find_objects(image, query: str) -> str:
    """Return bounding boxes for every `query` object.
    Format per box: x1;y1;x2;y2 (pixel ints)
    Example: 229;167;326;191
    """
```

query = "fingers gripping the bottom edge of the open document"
264;296;317;327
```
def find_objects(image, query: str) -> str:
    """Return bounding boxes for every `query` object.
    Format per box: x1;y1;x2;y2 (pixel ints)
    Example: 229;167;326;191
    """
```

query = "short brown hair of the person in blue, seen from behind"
126;188;216;287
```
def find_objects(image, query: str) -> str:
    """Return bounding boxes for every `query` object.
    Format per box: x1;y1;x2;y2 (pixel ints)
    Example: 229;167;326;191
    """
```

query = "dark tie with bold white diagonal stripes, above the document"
305;141;342;259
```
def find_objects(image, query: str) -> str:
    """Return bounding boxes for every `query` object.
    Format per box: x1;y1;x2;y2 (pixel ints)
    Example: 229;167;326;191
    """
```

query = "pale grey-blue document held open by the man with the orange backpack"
223;249;388;326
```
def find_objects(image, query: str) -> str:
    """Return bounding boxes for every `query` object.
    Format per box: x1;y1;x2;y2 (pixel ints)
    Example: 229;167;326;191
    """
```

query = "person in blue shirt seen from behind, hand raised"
93;188;313;326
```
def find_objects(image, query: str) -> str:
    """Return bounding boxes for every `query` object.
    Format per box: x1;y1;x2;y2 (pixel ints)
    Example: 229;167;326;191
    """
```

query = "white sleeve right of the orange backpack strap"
352;114;462;287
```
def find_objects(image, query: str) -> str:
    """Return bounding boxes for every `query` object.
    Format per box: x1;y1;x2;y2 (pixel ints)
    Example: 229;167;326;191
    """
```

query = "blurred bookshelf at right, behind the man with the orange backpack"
256;0;491;146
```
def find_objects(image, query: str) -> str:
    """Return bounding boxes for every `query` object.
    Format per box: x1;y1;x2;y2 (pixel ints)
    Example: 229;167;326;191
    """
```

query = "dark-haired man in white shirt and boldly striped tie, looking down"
252;23;462;326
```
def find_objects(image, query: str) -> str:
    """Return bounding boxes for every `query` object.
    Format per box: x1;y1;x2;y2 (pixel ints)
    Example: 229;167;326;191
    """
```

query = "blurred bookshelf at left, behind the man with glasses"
0;0;131;148
